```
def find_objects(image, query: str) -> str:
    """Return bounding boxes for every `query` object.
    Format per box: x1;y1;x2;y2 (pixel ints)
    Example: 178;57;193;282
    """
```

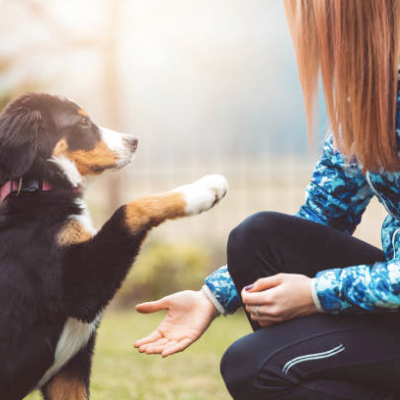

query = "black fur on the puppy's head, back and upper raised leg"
0;94;139;400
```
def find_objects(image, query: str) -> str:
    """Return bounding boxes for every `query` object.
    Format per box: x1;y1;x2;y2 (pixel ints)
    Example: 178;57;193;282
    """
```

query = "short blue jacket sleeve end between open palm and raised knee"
205;265;241;314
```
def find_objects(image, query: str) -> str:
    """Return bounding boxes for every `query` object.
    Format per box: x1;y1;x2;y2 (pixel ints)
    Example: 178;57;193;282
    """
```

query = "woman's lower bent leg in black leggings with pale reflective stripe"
221;314;400;400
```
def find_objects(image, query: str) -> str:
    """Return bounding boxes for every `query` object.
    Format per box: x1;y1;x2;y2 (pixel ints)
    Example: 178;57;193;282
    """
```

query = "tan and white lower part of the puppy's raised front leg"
125;175;228;234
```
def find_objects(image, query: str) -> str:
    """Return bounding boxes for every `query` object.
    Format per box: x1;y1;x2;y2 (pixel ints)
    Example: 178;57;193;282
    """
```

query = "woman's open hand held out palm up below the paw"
135;290;218;357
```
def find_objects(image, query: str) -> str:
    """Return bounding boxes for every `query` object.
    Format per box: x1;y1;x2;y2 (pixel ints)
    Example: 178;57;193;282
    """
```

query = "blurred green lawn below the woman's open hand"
27;311;250;400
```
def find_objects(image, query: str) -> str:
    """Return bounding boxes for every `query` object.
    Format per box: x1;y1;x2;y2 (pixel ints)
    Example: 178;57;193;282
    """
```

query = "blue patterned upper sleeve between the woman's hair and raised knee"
297;136;373;234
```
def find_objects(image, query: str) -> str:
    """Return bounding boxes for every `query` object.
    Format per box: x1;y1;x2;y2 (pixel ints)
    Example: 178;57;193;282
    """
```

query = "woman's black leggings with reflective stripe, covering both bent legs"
221;212;400;400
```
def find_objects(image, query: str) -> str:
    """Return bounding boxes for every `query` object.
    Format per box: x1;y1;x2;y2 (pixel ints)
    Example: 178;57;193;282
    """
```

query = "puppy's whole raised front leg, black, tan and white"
64;175;228;322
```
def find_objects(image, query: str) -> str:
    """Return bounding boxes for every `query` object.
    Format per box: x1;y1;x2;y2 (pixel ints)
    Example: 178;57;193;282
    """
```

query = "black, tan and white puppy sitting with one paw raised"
0;94;227;400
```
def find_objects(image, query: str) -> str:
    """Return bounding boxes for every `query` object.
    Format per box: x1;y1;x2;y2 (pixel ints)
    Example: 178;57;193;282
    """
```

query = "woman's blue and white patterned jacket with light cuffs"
206;98;400;314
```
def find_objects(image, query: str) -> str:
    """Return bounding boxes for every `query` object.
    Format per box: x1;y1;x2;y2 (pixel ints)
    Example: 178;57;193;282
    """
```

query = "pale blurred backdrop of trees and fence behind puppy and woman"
0;0;384;398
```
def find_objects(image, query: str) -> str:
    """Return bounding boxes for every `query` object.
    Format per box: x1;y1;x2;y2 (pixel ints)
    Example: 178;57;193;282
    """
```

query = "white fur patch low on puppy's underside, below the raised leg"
37;315;101;387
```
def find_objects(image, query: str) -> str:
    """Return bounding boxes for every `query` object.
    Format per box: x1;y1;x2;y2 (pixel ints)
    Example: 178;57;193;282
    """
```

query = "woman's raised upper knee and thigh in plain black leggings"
228;212;385;293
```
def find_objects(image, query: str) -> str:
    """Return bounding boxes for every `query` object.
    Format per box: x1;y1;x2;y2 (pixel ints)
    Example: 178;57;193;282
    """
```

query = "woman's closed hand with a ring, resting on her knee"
242;274;318;327
